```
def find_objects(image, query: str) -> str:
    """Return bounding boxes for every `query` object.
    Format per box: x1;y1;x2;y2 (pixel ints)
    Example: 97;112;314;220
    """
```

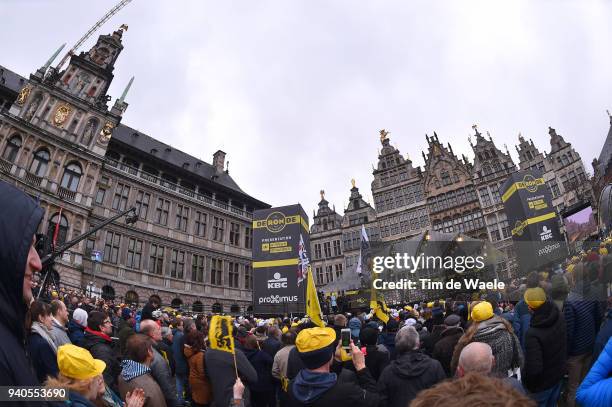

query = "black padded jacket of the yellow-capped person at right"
523;301;567;393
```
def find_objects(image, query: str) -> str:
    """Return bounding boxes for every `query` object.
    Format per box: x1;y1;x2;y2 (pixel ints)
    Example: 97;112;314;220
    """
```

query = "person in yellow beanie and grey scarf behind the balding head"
450;301;520;376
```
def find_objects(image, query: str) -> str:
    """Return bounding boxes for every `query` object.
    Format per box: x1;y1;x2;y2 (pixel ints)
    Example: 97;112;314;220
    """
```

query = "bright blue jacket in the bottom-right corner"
576;338;612;407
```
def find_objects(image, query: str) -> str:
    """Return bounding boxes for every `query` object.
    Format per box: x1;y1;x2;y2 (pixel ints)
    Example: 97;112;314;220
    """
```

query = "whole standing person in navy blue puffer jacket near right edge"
563;264;603;407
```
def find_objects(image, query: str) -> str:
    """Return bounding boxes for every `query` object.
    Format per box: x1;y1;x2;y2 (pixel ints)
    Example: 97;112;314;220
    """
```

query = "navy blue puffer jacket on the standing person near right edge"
563;283;601;356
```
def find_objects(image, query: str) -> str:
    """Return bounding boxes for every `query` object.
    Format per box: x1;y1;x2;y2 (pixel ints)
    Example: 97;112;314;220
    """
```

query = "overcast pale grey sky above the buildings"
0;0;612;220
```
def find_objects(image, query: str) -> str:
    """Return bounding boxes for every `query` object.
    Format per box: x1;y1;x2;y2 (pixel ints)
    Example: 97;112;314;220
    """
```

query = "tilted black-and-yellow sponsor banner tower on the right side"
501;170;567;276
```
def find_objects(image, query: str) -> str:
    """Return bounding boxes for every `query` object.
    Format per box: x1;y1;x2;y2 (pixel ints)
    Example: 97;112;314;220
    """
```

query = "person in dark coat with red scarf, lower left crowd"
82;311;121;393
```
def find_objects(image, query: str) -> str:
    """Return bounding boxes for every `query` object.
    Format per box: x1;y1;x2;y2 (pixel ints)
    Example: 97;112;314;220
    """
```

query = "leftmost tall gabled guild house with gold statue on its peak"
372;129;429;241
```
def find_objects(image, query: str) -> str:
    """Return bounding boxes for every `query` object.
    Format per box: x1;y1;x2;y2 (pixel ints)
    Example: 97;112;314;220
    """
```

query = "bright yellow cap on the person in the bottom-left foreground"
57;344;106;380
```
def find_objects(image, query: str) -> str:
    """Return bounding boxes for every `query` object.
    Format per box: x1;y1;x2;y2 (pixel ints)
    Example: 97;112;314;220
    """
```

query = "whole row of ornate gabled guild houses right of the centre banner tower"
310;126;596;287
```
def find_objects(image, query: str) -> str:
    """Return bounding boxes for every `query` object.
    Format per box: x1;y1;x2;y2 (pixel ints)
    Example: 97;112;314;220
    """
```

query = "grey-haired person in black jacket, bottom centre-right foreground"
378;326;446;407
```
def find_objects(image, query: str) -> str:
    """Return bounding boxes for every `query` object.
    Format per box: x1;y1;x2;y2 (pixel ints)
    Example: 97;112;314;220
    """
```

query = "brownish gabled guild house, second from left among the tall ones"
423;132;487;239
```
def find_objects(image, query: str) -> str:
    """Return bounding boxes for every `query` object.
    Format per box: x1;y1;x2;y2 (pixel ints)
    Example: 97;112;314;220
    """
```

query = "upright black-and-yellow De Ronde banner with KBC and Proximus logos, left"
253;204;310;314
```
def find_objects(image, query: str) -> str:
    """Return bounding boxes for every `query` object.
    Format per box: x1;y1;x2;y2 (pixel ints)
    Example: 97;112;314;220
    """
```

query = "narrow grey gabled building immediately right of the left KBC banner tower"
310;190;345;285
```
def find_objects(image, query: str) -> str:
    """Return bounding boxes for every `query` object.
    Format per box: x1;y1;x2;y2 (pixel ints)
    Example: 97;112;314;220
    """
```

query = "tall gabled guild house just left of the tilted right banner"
470;125;516;276
